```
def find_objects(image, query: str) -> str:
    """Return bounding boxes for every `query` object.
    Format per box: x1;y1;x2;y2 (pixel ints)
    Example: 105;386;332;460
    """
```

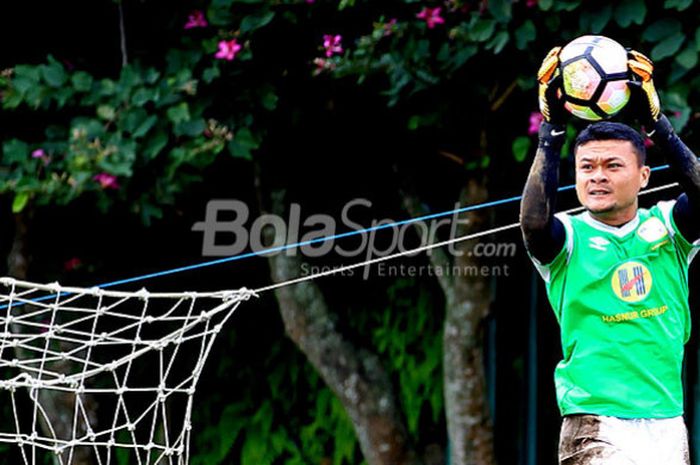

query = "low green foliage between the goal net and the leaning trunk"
192;340;359;465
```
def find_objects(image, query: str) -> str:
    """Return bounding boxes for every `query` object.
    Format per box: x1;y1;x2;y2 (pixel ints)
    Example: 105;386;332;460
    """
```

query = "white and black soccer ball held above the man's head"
559;35;630;121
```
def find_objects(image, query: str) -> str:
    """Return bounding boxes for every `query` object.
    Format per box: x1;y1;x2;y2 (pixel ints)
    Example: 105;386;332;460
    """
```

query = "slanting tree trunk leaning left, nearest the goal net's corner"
262;188;420;465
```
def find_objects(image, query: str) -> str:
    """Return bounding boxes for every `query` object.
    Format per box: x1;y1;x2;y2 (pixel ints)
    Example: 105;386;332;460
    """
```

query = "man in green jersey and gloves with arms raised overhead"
521;47;700;465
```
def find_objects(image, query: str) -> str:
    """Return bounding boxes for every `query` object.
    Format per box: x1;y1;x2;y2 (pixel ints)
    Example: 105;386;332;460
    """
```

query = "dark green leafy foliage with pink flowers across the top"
5;0;700;222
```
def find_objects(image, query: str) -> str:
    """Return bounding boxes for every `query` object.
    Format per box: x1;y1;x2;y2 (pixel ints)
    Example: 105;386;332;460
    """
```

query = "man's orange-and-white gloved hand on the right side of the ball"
627;50;661;131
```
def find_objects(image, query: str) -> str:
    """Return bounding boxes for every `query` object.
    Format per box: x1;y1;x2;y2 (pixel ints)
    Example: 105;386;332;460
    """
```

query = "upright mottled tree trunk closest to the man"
404;180;495;465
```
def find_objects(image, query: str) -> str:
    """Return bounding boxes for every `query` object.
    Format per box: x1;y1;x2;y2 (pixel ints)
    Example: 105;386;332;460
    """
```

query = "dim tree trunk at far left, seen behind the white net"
7;208;97;465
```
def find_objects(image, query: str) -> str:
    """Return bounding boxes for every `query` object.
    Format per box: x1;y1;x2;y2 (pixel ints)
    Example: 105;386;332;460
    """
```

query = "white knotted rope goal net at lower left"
0;278;255;465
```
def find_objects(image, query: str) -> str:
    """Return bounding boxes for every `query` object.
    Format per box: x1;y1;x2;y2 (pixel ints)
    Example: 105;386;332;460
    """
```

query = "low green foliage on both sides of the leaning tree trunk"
192;280;443;465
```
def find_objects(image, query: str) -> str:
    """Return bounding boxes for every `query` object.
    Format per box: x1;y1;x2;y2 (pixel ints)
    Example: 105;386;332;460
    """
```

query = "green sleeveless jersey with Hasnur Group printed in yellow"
533;201;698;418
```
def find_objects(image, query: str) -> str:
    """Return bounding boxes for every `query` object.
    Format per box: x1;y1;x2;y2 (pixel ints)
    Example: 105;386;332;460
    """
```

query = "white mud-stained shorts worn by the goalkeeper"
559;415;690;465
